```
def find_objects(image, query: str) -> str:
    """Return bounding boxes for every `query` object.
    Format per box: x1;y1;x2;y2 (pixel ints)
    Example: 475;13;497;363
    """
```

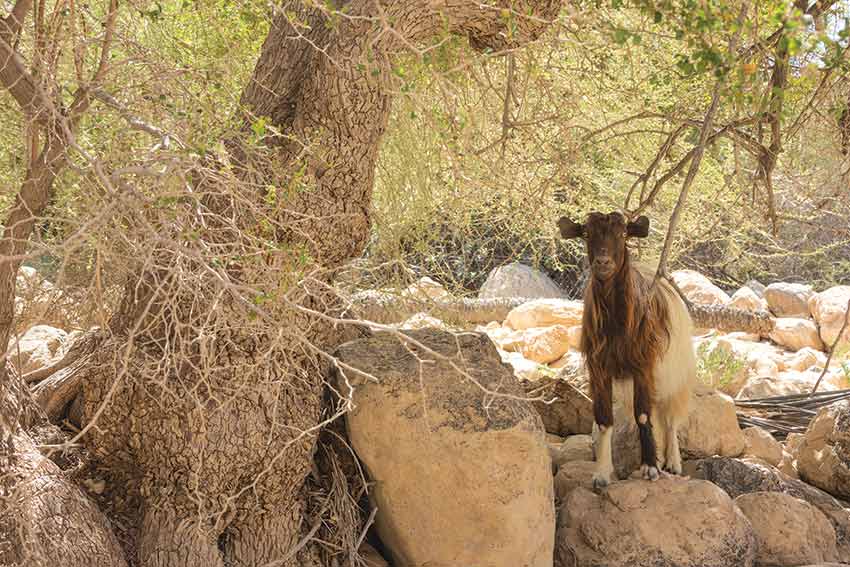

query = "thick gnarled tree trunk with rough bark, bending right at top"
71;0;560;567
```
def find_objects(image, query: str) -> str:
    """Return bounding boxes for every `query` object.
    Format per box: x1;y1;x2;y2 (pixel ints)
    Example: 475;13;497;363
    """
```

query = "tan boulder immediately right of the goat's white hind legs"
679;387;747;457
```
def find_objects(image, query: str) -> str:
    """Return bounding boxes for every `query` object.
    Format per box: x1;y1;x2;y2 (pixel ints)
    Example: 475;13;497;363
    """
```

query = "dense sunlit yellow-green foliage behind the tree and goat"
0;0;850;302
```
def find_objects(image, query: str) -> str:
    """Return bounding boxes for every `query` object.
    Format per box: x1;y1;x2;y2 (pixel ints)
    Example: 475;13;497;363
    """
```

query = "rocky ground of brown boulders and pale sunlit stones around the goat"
8;265;850;567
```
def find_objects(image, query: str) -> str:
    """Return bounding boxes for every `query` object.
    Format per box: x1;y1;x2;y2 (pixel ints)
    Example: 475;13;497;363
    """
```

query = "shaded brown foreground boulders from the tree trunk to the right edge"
337;330;850;567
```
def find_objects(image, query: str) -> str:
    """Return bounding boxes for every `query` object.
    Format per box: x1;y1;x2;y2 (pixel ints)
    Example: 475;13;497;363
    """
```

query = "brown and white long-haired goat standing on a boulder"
558;212;696;488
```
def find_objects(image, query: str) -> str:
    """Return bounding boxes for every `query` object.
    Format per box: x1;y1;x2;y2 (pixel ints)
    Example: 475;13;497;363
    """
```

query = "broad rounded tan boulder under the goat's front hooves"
556;478;756;567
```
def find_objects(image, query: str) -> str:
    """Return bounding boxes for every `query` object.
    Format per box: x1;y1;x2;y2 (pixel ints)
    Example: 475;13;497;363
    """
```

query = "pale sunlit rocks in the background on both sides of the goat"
464;268;850;399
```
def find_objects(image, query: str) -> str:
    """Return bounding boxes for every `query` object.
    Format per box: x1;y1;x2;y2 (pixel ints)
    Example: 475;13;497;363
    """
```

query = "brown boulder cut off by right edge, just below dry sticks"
796;401;850;498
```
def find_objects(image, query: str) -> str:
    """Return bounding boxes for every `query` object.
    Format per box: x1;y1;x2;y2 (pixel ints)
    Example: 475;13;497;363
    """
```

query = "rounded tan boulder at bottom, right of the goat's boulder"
735;492;838;567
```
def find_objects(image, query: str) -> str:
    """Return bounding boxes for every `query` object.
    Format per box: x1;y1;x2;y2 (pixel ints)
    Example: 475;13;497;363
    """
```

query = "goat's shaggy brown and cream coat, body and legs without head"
581;253;696;484
